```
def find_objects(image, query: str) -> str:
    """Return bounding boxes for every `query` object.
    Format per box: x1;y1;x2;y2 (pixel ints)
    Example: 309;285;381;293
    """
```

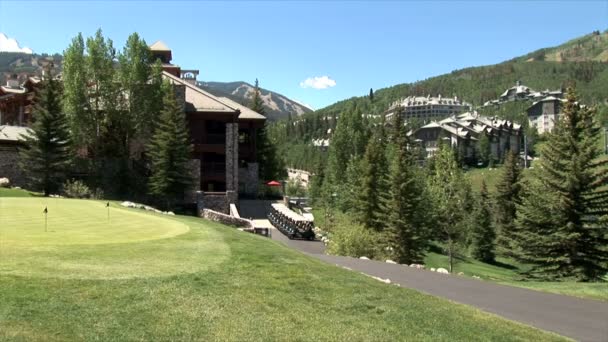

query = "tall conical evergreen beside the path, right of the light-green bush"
383;113;429;264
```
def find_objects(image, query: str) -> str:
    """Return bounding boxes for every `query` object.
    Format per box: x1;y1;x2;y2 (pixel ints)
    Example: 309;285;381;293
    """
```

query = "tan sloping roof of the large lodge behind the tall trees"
163;71;239;114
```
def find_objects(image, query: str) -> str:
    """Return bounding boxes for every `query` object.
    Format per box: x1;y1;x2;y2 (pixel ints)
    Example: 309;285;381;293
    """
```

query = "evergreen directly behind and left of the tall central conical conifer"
355;117;389;230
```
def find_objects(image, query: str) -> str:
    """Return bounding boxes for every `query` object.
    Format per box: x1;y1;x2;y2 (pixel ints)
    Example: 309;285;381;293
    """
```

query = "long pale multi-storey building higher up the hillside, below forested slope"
386;95;471;122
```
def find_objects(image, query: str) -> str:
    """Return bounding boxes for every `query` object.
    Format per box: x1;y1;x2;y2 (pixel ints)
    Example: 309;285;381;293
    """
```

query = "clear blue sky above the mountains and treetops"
0;0;608;108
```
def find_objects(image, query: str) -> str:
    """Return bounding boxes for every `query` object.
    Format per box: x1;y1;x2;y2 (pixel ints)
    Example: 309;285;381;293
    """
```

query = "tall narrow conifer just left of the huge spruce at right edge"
494;152;521;256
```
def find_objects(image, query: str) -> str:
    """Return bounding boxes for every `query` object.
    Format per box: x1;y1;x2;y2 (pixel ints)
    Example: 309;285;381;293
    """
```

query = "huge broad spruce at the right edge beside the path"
516;88;608;281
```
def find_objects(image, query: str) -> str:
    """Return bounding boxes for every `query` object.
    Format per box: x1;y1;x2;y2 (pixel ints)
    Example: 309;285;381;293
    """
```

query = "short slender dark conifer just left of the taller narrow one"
471;181;496;262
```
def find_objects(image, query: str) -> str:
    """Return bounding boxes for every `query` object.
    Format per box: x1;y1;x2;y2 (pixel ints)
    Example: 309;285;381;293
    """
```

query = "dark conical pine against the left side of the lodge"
148;84;192;207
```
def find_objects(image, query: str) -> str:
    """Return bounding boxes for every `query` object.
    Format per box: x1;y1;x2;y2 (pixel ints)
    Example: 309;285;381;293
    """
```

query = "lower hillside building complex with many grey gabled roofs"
409;112;523;164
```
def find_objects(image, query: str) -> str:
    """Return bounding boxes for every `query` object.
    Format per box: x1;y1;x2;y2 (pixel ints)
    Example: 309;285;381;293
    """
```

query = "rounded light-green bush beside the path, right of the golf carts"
327;222;381;259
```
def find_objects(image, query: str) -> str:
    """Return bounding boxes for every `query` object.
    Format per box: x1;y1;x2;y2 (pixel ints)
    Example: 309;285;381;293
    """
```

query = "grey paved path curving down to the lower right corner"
241;200;608;342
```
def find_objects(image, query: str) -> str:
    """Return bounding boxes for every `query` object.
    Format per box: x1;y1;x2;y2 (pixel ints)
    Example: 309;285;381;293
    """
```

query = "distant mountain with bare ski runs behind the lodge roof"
197;82;313;121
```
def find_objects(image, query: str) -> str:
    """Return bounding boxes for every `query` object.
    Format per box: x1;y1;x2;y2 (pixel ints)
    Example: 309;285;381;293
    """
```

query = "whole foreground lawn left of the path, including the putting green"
0;198;565;341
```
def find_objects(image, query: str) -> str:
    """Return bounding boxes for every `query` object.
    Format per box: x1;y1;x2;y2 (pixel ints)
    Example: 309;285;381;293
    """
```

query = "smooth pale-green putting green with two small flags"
0;198;230;279
